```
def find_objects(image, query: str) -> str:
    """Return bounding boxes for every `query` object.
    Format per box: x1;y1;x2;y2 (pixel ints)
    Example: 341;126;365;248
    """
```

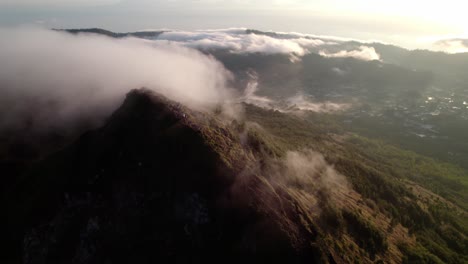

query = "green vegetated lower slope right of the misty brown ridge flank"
246;105;468;263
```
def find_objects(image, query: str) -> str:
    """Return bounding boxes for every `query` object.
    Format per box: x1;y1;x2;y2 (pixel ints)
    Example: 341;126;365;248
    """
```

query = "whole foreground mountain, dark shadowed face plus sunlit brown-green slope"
0;90;468;263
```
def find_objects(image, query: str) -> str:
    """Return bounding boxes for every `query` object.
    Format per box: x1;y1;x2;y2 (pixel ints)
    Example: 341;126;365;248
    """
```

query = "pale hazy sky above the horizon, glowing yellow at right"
0;0;468;48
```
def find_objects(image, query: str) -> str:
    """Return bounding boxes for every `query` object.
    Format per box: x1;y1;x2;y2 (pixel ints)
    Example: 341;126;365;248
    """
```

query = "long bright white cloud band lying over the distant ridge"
149;28;380;60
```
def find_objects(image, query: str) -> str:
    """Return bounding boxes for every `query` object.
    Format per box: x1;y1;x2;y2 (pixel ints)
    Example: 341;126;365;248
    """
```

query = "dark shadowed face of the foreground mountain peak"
3;90;323;263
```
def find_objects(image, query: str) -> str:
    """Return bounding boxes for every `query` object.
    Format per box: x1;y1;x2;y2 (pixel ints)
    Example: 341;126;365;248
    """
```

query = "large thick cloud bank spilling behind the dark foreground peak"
0;28;232;132
